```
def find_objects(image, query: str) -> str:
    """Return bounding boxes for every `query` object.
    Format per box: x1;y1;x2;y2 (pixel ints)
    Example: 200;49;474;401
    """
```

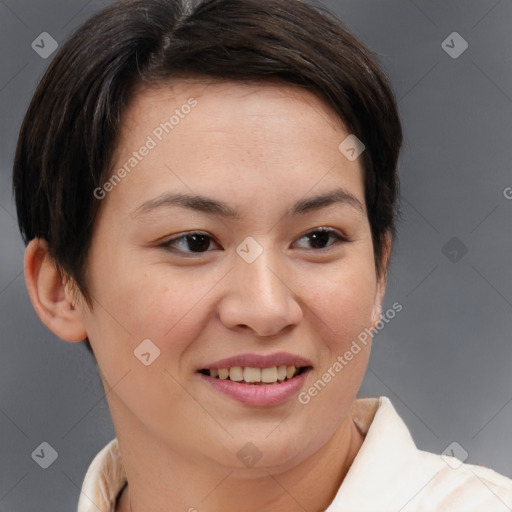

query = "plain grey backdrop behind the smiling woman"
0;0;512;512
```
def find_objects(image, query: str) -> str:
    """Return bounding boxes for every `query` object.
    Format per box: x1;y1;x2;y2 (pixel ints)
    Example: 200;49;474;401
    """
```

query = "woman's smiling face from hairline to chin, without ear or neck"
80;81;383;468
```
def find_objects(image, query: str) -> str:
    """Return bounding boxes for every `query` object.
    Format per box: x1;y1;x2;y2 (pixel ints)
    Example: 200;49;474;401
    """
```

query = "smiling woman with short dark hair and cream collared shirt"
14;0;512;512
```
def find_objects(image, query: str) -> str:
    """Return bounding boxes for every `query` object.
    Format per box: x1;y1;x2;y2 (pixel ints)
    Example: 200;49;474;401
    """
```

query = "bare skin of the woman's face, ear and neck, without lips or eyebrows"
25;81;390;512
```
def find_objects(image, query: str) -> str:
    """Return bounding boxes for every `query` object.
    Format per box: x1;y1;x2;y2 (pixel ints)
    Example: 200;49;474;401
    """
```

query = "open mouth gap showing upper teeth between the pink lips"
199;365;311;386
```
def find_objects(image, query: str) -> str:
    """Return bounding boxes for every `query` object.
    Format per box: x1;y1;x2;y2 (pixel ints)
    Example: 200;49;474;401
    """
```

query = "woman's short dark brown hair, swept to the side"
13;0;402;352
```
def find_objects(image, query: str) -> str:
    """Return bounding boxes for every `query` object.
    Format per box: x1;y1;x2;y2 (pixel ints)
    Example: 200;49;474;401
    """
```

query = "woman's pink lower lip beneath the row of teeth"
198;368;310;407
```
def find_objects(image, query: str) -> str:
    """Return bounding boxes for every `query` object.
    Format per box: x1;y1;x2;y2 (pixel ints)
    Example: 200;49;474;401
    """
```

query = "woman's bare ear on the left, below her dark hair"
25;238;87;342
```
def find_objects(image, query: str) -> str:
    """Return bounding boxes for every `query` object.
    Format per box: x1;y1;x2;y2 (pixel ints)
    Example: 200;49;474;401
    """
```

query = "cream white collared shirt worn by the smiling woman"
78;396;512;512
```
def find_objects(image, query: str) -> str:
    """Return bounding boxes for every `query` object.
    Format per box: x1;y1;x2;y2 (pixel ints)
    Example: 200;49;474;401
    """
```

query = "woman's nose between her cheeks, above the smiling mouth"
218;250;303;336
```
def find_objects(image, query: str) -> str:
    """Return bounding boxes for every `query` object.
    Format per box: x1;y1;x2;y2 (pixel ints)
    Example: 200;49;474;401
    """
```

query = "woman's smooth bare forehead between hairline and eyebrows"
102;80;364;217
